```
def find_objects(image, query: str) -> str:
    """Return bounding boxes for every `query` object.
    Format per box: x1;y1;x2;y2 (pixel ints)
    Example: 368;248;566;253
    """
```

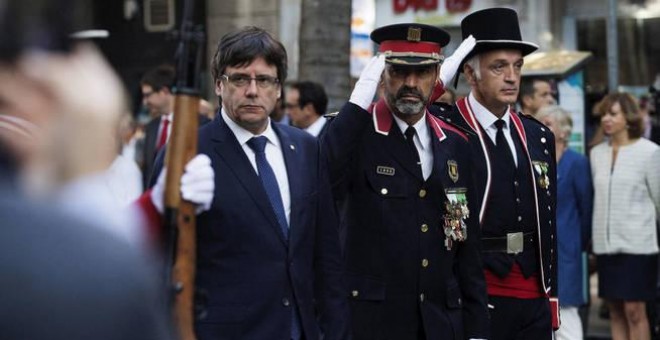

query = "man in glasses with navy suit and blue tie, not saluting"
151;27;348;340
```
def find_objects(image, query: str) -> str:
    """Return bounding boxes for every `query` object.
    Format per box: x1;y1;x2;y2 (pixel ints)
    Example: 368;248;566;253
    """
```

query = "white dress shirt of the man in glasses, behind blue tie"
222;109;291;224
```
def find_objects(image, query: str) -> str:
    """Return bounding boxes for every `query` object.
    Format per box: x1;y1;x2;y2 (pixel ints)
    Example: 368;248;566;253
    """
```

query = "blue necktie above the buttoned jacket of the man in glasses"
247;136;289;239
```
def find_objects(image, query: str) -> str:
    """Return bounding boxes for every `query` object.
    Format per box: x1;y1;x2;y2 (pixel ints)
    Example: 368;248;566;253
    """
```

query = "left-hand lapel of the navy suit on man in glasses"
211;117;287;244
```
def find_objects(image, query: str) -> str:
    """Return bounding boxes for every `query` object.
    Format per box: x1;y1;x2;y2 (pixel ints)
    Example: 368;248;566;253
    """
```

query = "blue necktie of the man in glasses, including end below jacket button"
247;136;301;340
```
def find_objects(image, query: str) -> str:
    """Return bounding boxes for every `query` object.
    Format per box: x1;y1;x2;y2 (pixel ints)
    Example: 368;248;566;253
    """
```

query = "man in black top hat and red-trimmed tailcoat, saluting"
435;8;558;340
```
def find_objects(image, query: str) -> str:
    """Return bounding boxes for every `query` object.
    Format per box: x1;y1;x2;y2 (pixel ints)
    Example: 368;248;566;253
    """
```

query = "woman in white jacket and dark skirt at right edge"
589;93;660;340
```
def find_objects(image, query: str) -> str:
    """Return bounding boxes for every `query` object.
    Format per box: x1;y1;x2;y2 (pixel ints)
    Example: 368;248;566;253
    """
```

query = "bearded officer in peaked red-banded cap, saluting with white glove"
323;24;488;340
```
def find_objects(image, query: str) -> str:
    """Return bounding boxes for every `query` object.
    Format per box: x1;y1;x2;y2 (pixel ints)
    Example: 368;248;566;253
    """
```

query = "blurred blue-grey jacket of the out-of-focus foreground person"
0;173;173;340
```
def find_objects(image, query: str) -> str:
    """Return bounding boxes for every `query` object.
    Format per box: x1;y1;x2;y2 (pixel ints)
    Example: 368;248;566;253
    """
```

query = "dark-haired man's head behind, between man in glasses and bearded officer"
285;81;328;139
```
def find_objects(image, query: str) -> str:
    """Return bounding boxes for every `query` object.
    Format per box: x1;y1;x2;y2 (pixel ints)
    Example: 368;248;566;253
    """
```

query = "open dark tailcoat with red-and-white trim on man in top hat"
432;98;557;297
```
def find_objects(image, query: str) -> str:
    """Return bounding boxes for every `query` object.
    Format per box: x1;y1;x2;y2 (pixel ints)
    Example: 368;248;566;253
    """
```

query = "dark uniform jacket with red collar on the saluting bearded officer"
323;102;489;340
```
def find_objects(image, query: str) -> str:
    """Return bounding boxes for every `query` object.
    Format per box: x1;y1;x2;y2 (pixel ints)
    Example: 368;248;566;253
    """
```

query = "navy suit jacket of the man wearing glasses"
153;115;348;340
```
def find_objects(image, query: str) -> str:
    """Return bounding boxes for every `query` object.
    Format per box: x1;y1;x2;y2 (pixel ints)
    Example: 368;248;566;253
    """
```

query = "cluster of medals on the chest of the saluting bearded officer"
444;188;470;250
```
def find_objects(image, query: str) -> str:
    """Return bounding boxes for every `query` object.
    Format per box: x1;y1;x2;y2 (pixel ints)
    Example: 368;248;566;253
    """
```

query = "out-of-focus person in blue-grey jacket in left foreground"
0;0;171;340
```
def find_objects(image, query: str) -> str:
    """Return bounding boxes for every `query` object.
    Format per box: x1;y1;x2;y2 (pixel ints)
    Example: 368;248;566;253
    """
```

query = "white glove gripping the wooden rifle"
151;154;215;214
